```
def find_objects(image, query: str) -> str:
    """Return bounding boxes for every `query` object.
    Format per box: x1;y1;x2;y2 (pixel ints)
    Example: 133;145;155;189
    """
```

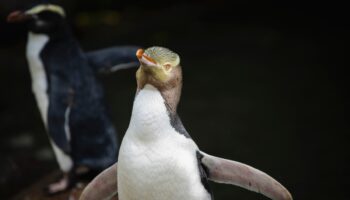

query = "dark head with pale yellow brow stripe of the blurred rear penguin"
7;3;65;35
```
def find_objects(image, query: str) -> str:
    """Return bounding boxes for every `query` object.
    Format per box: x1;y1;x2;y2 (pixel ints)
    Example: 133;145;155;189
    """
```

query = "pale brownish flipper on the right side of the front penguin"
200;152;293;200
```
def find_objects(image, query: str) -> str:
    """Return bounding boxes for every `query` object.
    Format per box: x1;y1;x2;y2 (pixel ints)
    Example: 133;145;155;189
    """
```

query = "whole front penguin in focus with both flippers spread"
80;47;292;200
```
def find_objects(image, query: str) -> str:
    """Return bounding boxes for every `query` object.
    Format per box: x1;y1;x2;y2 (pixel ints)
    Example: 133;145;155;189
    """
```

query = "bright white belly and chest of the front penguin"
118;85;210;200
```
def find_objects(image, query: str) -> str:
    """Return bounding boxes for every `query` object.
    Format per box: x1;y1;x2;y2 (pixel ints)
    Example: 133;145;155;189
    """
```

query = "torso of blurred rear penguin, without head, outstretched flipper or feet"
20;7;117;172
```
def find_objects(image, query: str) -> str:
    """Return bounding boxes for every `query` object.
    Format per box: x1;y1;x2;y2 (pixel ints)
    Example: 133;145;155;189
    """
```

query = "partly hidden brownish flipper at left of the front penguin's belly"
79;163;118;200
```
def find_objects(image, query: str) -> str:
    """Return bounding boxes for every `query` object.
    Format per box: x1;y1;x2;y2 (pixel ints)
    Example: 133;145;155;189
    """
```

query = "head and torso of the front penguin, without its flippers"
118;47;212;200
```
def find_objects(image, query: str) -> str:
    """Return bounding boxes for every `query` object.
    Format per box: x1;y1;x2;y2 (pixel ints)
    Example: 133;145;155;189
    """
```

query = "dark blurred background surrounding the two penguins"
0;0;350;199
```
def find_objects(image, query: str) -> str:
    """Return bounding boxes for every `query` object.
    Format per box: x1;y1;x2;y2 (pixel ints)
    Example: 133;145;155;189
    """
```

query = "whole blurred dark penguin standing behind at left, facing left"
7;4;138;194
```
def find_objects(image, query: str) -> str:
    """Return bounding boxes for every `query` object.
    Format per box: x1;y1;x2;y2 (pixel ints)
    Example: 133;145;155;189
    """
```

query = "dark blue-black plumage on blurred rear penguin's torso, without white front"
40;27;117;169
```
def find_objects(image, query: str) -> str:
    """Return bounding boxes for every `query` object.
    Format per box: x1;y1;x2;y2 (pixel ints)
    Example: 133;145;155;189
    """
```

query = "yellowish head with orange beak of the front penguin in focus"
136;47;182;89
